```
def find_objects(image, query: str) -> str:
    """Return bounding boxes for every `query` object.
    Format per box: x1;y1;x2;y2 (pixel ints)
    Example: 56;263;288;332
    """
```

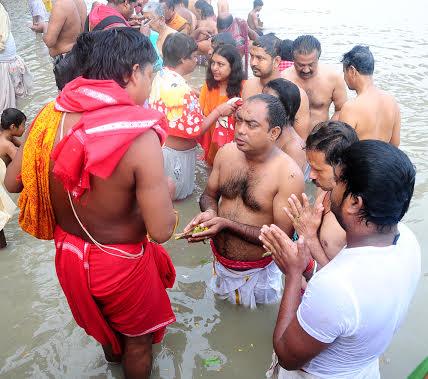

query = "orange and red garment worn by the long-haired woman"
198;83;242;166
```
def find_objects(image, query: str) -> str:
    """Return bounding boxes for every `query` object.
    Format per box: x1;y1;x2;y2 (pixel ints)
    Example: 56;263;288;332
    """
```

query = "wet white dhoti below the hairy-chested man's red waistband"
210;259;283;309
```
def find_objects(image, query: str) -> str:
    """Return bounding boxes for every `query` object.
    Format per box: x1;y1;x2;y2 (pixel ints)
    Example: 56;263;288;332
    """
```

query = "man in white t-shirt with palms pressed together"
260;140;421;379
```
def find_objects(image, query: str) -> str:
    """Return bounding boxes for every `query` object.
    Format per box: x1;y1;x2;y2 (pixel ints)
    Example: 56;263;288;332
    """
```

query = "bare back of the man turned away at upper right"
339;87;400;146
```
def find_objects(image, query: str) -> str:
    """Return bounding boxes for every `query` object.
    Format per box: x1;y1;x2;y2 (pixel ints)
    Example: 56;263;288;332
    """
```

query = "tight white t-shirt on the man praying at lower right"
297;224;421;379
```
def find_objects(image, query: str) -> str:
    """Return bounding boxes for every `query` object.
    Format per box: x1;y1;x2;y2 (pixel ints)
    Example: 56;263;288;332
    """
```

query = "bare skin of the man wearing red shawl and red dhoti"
5;65;176;379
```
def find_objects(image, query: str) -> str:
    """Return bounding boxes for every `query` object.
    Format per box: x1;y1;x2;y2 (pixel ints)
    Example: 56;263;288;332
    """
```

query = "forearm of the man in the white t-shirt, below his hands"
273;274;302;350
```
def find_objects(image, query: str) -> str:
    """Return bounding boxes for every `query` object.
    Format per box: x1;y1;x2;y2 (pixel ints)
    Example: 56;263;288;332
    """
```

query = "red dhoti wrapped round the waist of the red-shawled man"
54;226;175;354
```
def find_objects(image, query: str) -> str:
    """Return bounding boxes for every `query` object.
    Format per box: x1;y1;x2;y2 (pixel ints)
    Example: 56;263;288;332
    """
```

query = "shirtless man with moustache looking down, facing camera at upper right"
282;35;347;128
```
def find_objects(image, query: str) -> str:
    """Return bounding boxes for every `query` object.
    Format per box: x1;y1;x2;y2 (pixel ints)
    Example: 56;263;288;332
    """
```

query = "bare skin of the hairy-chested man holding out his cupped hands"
184;101;303;261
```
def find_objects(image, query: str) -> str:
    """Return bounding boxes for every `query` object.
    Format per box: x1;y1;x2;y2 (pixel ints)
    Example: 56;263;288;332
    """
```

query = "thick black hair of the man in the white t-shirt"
339;140;416;233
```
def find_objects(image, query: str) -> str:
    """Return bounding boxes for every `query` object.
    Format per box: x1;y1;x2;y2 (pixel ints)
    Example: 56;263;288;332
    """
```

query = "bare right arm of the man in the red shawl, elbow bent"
133;130;176;243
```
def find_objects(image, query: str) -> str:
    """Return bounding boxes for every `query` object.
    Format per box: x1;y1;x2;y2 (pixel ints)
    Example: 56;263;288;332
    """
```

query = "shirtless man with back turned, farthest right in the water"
339;45;401;147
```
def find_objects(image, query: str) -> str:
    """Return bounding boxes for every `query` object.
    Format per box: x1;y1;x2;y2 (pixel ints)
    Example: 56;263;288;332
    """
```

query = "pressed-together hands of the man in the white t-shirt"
260;225;312;275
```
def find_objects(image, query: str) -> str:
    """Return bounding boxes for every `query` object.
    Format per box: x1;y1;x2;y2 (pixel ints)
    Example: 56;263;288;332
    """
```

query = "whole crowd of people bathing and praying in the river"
0;0;421;379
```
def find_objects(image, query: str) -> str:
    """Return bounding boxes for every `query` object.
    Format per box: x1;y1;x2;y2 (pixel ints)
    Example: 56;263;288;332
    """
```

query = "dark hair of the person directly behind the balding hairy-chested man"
265;78;301;126
